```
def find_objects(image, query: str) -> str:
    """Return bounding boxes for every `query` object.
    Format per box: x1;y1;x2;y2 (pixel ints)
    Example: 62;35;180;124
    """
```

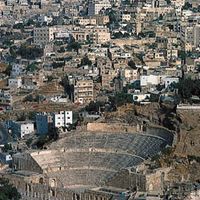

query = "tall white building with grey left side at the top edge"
88;0;111;16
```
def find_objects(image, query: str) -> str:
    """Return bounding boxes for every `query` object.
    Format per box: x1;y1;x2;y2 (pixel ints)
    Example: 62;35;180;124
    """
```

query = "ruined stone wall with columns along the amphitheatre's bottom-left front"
0;174;117;200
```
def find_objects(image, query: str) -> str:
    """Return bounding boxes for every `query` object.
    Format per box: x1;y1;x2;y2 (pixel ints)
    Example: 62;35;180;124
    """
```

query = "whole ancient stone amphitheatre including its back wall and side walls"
9;123;174;200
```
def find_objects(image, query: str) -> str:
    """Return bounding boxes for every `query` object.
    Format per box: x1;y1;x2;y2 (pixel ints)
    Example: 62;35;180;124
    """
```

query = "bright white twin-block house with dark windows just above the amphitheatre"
53;111;73;128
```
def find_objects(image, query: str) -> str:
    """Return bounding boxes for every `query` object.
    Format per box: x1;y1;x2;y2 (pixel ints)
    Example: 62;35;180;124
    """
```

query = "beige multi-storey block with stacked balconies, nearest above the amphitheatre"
74;78;94;104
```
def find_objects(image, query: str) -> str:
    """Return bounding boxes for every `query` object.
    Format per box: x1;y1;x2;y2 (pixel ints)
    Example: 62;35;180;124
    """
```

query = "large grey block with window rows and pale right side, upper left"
33;27;55;45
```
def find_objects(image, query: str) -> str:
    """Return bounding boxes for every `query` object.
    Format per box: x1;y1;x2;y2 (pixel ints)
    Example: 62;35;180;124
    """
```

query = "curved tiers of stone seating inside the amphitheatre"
31;133;170;187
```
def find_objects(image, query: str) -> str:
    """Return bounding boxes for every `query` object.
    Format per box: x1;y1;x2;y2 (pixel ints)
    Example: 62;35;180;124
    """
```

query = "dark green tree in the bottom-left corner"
0;178;21;200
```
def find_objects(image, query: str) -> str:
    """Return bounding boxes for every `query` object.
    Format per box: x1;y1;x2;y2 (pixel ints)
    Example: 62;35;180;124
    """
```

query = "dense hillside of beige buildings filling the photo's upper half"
0;0;200;111
